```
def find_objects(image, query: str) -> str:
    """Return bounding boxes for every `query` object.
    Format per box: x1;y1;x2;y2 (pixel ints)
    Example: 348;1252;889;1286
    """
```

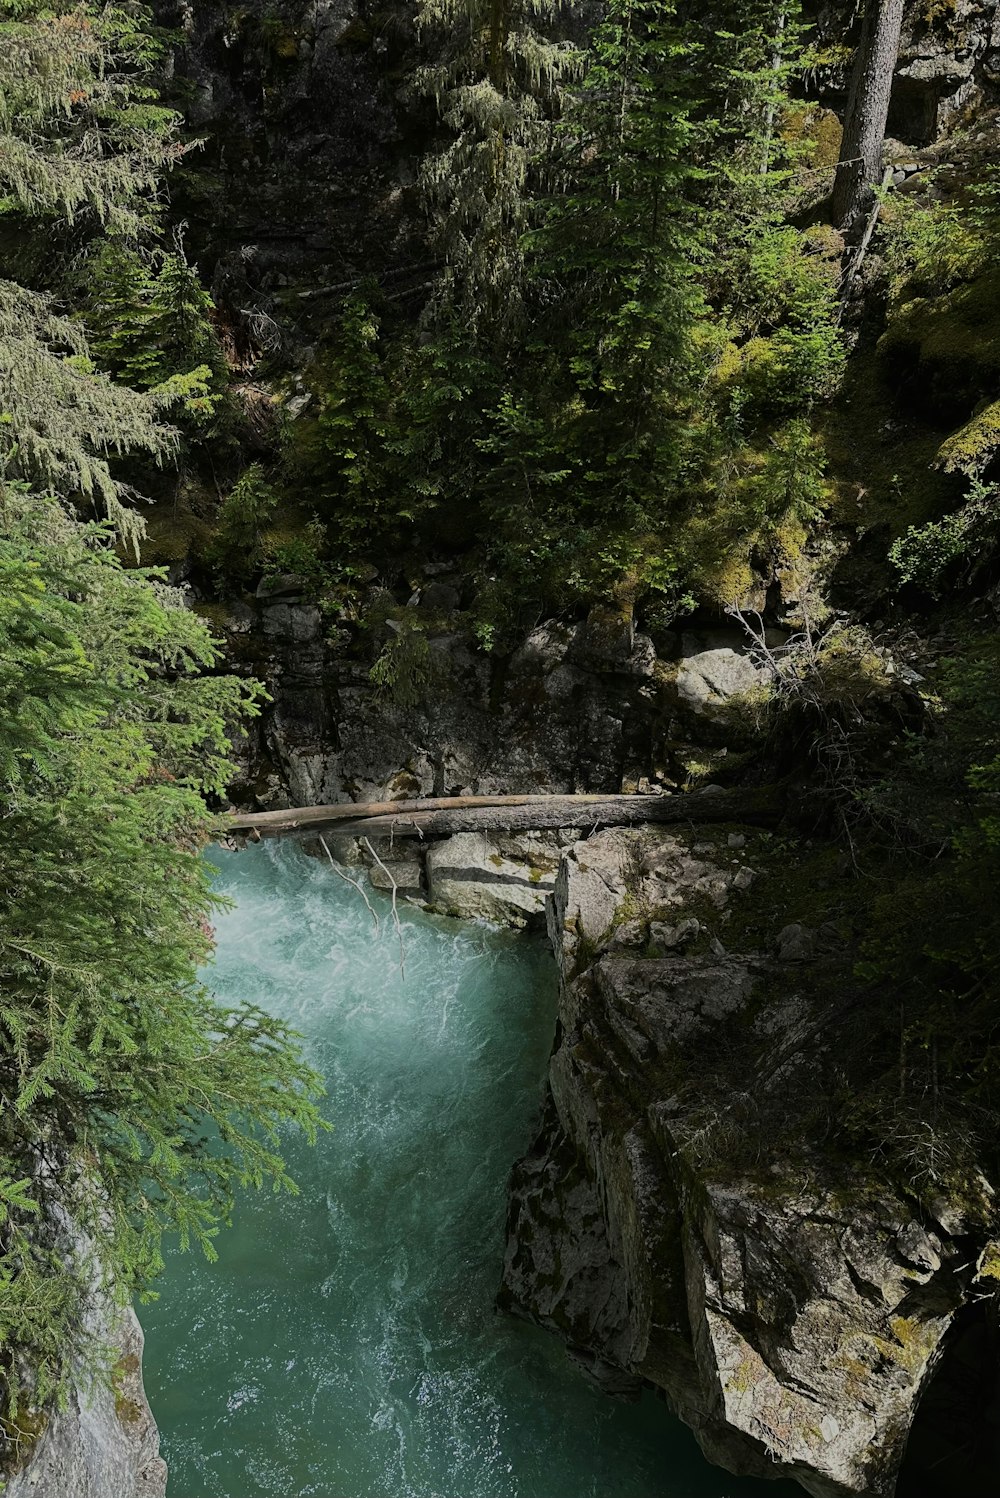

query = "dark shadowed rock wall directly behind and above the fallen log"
219;580;778;809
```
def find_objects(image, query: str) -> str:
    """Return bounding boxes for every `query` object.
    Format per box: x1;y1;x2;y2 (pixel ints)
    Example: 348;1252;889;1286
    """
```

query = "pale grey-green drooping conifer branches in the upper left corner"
0;0;222;548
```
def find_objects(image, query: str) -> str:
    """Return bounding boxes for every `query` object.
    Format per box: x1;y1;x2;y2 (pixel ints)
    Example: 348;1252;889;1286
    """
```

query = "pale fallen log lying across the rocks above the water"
226;788;784;837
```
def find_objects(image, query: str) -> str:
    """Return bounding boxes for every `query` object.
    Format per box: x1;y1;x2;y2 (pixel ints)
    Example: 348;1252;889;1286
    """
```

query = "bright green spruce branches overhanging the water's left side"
0;485;317;1407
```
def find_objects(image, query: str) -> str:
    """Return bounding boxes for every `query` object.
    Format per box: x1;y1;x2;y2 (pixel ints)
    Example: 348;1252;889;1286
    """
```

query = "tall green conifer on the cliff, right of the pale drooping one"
481;0;702;601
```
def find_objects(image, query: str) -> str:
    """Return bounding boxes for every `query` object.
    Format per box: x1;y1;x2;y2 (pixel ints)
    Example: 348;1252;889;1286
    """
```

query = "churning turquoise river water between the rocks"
142;843;777;1498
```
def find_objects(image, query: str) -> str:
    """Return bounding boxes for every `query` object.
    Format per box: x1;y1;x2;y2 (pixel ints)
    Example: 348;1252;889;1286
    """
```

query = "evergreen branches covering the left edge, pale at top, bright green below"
0;0;324;1443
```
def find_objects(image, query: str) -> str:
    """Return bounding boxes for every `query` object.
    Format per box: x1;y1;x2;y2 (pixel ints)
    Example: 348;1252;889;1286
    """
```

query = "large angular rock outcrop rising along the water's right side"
500;831;991;1498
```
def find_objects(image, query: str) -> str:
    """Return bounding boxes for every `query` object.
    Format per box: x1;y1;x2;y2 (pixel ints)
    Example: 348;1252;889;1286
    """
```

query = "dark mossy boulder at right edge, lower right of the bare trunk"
879;271;1000;424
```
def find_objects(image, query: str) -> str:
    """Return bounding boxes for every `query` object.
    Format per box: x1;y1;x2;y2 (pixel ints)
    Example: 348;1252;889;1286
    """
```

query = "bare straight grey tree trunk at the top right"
834;0;904;232
